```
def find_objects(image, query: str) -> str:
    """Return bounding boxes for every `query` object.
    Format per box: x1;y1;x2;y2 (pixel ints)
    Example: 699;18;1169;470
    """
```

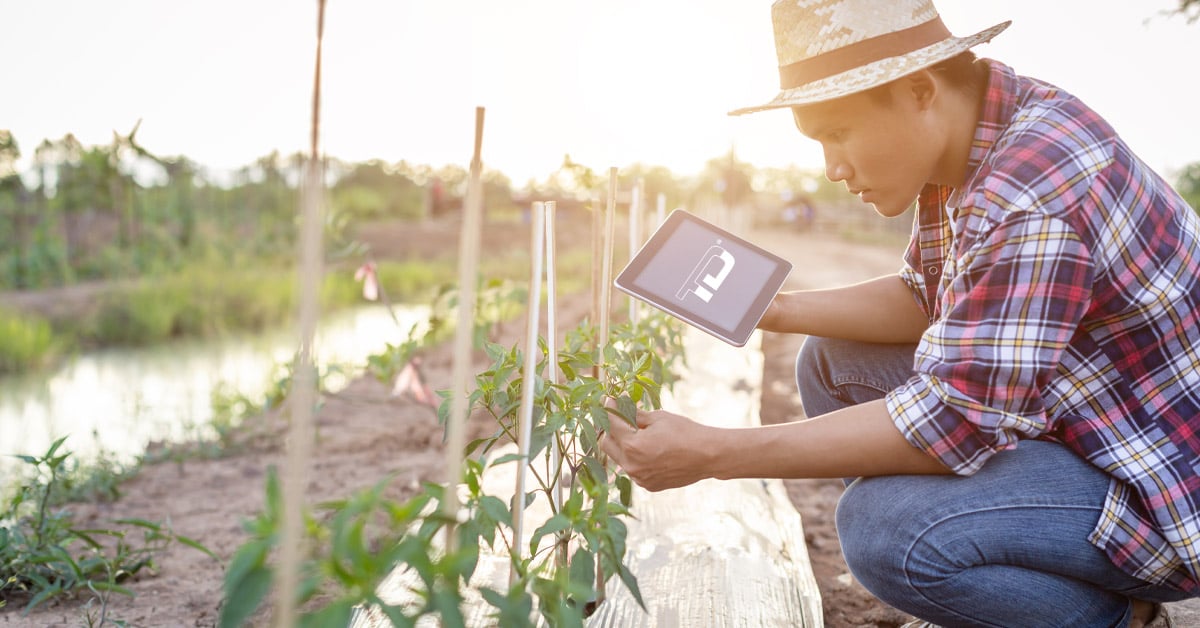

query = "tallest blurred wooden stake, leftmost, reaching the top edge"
275;0;325;628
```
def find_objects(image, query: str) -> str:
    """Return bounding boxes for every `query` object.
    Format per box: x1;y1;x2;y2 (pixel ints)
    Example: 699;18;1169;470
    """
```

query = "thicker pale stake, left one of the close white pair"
509;202;546;587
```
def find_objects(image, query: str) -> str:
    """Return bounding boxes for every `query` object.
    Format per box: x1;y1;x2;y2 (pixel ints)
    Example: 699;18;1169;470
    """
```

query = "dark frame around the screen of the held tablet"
613;209;792;347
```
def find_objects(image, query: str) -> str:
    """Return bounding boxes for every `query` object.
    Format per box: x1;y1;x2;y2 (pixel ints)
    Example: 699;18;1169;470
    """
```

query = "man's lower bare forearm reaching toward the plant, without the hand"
710;400;949;479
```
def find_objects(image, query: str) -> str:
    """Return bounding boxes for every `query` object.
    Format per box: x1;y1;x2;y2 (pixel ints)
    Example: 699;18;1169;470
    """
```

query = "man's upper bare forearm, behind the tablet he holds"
758;275;929;342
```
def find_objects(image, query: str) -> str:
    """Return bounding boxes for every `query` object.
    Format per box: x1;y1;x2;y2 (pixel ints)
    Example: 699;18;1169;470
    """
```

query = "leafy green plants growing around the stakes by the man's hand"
221;315;683;627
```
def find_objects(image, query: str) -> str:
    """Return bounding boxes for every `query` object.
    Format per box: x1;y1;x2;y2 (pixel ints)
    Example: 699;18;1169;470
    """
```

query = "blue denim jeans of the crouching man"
796;337;1189;628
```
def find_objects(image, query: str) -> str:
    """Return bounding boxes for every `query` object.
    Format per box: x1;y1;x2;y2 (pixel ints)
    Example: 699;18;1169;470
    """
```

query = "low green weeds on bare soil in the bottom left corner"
0;437;217;623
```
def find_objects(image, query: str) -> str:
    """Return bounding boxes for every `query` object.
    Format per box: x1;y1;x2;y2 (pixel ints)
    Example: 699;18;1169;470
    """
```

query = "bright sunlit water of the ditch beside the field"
0;306;428;484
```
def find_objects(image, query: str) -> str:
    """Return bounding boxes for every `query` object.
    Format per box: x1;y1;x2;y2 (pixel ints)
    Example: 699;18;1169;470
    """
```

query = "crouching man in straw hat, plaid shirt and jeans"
602;0;1200;627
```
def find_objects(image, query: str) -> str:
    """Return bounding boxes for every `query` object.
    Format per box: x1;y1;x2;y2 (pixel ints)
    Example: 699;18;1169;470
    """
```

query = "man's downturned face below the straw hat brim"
792;79;937;217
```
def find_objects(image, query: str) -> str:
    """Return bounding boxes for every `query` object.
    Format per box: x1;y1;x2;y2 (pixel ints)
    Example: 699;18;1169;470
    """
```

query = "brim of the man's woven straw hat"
730;22;1012;115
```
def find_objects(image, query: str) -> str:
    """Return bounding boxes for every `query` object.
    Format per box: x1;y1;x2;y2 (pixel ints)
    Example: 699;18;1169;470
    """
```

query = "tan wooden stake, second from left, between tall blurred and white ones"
442;107;484;551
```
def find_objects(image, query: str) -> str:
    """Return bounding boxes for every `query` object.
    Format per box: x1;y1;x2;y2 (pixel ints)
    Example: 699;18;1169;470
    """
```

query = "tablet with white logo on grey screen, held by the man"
613;209;792;347
